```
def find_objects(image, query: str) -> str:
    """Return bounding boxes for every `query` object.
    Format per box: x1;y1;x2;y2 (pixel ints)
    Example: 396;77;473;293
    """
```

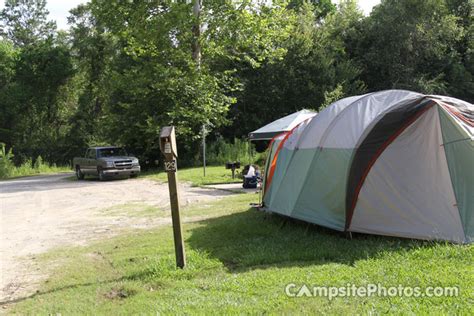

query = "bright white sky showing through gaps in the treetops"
0;0;380;29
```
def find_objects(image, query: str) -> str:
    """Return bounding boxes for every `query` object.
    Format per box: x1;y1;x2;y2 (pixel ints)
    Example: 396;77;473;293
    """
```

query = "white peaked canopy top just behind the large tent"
249;110;317;141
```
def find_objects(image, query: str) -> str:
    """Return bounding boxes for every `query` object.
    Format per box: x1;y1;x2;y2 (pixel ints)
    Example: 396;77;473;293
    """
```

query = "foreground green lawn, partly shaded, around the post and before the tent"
9;194;474;315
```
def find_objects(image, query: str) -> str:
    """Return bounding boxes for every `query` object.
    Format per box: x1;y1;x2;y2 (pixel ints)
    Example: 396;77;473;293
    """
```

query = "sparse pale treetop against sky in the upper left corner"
0;0;56;47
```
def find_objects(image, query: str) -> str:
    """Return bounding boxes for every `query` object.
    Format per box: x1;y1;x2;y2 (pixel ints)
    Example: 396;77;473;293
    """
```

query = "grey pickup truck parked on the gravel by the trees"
72;146;140;180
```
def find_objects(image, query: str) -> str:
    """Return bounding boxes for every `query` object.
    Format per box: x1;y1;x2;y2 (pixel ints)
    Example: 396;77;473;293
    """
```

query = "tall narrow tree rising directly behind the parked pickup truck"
68;4;116;156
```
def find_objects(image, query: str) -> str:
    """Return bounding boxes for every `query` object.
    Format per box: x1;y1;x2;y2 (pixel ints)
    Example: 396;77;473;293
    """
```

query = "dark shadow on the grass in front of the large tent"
187;209;435;272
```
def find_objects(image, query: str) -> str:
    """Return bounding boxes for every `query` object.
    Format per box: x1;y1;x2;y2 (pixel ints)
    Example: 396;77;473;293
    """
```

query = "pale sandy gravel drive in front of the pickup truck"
0;174;229;302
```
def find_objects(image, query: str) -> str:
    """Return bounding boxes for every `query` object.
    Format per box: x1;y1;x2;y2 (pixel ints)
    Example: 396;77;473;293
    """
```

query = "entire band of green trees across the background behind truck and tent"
0;0;474;165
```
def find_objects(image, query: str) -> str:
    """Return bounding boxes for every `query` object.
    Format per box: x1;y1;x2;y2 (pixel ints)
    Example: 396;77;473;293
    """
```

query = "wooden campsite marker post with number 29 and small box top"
160;126;186;269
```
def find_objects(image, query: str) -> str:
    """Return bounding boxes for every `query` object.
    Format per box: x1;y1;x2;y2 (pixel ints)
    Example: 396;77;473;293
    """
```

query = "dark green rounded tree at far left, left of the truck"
7;41;74;162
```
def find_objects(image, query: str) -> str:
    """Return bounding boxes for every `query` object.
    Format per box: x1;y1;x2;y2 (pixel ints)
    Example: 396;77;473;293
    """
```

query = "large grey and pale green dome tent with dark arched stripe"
263;90;474;243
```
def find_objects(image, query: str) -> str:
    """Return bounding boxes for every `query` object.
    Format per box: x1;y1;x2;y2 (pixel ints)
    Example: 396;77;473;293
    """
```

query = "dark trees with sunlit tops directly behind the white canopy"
222;2;366;138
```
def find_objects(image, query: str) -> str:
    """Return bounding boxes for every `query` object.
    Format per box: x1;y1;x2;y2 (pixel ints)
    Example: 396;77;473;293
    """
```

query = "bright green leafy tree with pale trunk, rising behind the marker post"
64;0;289;160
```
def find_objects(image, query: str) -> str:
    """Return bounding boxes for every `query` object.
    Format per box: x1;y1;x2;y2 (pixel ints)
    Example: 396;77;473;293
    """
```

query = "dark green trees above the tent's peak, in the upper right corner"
349;0;474;102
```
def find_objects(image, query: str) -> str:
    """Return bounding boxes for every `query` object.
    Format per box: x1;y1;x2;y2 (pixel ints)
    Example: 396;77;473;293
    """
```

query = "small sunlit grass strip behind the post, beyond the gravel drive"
142;166;242;186
